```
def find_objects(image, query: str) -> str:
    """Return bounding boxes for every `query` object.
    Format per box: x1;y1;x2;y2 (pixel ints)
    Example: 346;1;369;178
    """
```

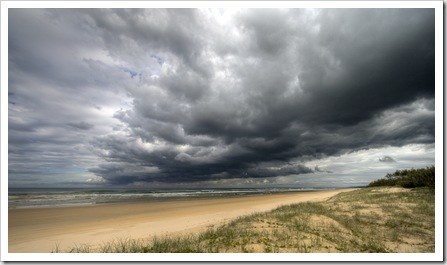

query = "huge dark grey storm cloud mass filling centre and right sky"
86;9;434;182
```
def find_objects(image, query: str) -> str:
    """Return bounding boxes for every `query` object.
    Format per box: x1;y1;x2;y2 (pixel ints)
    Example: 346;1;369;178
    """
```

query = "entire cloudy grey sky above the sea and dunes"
8;8;435;187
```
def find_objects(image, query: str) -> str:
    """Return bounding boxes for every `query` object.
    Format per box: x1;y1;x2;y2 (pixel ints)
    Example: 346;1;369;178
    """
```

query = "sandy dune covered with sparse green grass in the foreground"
57;187;435;253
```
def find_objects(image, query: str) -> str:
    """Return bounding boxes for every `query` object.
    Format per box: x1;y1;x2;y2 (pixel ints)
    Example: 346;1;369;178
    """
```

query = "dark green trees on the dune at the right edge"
368;166;435;190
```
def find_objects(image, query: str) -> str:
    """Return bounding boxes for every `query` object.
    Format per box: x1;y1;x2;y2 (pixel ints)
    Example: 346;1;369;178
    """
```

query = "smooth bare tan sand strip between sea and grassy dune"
8;189;353;253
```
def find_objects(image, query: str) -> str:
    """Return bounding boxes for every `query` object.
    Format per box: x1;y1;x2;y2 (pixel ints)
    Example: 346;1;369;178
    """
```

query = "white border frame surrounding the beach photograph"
0;1;444;261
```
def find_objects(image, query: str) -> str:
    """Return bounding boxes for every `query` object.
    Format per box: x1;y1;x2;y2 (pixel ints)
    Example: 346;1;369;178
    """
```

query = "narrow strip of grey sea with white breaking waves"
8;188;326;208
